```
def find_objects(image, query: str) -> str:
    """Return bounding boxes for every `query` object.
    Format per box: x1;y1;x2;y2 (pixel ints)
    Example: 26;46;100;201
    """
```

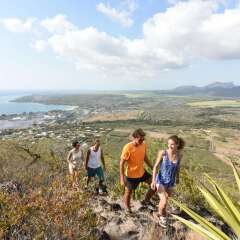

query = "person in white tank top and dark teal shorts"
85;138;106;193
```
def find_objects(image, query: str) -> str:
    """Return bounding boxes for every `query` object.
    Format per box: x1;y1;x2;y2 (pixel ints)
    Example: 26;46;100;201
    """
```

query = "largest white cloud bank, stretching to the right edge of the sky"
3;0;240;80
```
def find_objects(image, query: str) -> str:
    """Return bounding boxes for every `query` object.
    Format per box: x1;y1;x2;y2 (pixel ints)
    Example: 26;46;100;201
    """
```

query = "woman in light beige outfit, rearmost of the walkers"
67;141;84;187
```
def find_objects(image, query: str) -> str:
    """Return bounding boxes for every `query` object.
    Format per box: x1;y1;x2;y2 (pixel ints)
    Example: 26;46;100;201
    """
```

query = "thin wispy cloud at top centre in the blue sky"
96;0;137;27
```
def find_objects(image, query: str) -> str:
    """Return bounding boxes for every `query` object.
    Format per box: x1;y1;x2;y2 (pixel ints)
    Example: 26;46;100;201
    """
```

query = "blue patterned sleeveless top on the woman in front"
156;151;180;188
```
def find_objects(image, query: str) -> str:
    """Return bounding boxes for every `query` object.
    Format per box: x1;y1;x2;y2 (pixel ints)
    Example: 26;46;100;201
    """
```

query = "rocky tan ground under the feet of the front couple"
90;194;203;240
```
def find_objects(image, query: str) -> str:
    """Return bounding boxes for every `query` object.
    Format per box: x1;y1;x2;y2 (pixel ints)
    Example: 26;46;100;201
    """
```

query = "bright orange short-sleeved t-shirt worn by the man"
121;142;146;178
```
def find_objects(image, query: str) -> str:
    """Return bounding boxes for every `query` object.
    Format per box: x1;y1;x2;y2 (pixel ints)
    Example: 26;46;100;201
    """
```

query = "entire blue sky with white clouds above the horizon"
0;0;240;90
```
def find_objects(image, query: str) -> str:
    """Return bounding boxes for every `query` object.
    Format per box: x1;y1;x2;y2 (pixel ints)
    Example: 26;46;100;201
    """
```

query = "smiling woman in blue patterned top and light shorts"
151;135;185;228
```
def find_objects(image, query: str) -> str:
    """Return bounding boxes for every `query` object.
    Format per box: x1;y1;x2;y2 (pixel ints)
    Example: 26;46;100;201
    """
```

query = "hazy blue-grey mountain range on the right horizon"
160;82;240;98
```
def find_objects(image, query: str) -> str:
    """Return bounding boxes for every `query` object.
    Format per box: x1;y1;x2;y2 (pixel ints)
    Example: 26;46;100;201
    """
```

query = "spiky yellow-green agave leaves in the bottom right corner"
172;162;240;240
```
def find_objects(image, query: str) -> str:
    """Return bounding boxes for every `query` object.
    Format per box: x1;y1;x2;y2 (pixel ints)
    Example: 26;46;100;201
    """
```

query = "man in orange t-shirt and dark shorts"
120;128;154;213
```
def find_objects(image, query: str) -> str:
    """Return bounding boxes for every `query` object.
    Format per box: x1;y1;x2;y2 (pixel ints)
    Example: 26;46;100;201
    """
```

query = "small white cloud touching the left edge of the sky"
0;18;36;33
